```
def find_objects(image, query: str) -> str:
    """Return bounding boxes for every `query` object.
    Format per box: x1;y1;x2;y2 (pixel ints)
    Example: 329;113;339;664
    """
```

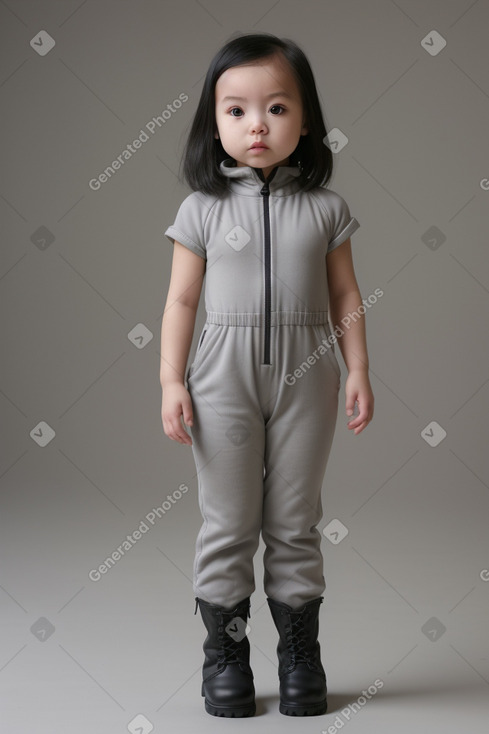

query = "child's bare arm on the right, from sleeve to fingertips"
326;242;374;434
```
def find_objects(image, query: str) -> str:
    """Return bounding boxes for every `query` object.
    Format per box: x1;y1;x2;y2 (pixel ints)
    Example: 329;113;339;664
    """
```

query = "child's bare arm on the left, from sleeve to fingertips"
160;240;206;445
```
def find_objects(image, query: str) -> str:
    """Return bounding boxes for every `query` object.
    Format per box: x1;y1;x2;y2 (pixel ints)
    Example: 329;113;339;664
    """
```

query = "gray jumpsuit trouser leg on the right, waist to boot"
262;326;340;608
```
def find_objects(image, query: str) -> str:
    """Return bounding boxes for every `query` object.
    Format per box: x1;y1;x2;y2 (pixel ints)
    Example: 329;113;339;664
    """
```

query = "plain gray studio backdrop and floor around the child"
0;0;489;734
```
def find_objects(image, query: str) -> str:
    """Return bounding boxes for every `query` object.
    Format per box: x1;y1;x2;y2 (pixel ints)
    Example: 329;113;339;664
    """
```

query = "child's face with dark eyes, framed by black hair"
215;55;308;176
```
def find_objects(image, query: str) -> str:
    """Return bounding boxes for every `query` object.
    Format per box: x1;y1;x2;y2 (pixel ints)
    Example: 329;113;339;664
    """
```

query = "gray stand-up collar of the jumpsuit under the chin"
220;158;300;196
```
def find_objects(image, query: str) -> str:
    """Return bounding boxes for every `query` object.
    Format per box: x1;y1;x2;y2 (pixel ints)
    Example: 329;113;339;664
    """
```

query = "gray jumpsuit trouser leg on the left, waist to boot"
188;325;265;608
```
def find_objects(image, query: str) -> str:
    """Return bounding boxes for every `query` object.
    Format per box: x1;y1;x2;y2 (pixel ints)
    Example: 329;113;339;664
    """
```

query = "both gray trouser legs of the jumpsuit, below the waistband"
187;323;340;607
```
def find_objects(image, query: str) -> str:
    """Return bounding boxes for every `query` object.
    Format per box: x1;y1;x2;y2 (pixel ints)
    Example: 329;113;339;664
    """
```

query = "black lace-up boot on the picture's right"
267;596;327;716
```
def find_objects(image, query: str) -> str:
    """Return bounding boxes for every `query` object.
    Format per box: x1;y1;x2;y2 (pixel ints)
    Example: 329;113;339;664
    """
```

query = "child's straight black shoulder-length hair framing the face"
177;33;333;196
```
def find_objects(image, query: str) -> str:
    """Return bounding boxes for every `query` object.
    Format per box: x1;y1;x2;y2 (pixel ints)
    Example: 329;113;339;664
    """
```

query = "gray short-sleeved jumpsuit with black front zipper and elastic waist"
165;158;360;608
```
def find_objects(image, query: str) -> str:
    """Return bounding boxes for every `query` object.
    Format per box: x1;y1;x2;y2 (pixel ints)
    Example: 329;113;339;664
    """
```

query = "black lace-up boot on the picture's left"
195;597;256;716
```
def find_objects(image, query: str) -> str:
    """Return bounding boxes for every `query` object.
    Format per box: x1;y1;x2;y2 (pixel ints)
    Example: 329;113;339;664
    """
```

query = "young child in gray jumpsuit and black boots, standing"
160;34;374;717
